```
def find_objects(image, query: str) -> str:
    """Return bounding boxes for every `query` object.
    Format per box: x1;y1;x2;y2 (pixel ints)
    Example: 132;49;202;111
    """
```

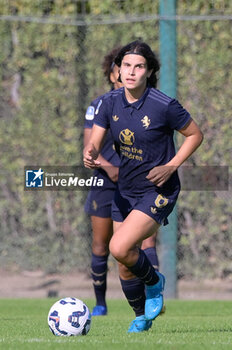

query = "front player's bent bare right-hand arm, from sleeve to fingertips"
147;119;203;186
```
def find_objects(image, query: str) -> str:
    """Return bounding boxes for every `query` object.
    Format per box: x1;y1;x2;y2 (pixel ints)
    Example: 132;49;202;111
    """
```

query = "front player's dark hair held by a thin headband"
114;40;160;87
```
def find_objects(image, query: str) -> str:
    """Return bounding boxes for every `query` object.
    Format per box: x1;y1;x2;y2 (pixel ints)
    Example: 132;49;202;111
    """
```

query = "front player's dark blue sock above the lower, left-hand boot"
120;278;146;317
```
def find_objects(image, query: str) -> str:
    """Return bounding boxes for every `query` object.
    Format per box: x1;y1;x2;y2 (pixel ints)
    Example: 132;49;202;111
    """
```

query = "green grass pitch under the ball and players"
0;299;232;350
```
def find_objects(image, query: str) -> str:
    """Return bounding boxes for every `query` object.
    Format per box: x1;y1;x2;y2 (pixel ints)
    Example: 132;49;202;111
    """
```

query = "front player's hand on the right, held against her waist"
146;165;176;187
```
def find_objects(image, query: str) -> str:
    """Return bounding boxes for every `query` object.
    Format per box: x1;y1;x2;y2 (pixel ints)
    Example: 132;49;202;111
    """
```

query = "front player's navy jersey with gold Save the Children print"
94;87;191;195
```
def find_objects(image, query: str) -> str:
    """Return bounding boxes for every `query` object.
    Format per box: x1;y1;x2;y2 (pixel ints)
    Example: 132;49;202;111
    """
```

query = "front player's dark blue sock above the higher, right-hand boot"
128;249;159;286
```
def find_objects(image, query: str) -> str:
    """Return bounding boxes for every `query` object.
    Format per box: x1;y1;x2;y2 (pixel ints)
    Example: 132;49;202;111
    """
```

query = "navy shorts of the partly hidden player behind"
85;171;117;218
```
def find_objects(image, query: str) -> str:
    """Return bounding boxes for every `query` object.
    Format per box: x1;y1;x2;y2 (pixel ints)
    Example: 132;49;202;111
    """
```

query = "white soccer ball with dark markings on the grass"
48;297;91;337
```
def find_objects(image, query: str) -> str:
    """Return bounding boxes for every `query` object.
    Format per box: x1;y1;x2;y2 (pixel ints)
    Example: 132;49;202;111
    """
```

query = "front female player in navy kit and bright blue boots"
83;41;203;332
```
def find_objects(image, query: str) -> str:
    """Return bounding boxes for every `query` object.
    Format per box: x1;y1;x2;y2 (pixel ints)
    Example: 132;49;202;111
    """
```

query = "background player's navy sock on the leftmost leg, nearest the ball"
91;253;108;306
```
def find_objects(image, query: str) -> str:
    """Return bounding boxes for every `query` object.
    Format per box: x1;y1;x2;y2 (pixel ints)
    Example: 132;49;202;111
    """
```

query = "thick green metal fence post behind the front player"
159;0;177;298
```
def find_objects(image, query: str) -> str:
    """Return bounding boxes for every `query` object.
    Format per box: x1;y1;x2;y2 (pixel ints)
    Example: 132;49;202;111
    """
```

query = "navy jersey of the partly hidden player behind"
84;97;120;167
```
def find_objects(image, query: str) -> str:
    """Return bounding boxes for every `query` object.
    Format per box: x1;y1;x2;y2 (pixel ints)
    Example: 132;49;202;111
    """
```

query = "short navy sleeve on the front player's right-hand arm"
166;99;191;130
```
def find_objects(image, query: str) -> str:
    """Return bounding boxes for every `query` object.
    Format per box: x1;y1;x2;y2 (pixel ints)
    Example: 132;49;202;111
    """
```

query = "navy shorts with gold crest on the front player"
112;189;179;225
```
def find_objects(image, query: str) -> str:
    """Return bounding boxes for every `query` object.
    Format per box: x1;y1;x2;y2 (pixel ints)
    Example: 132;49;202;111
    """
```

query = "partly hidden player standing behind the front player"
84;47;159;316
